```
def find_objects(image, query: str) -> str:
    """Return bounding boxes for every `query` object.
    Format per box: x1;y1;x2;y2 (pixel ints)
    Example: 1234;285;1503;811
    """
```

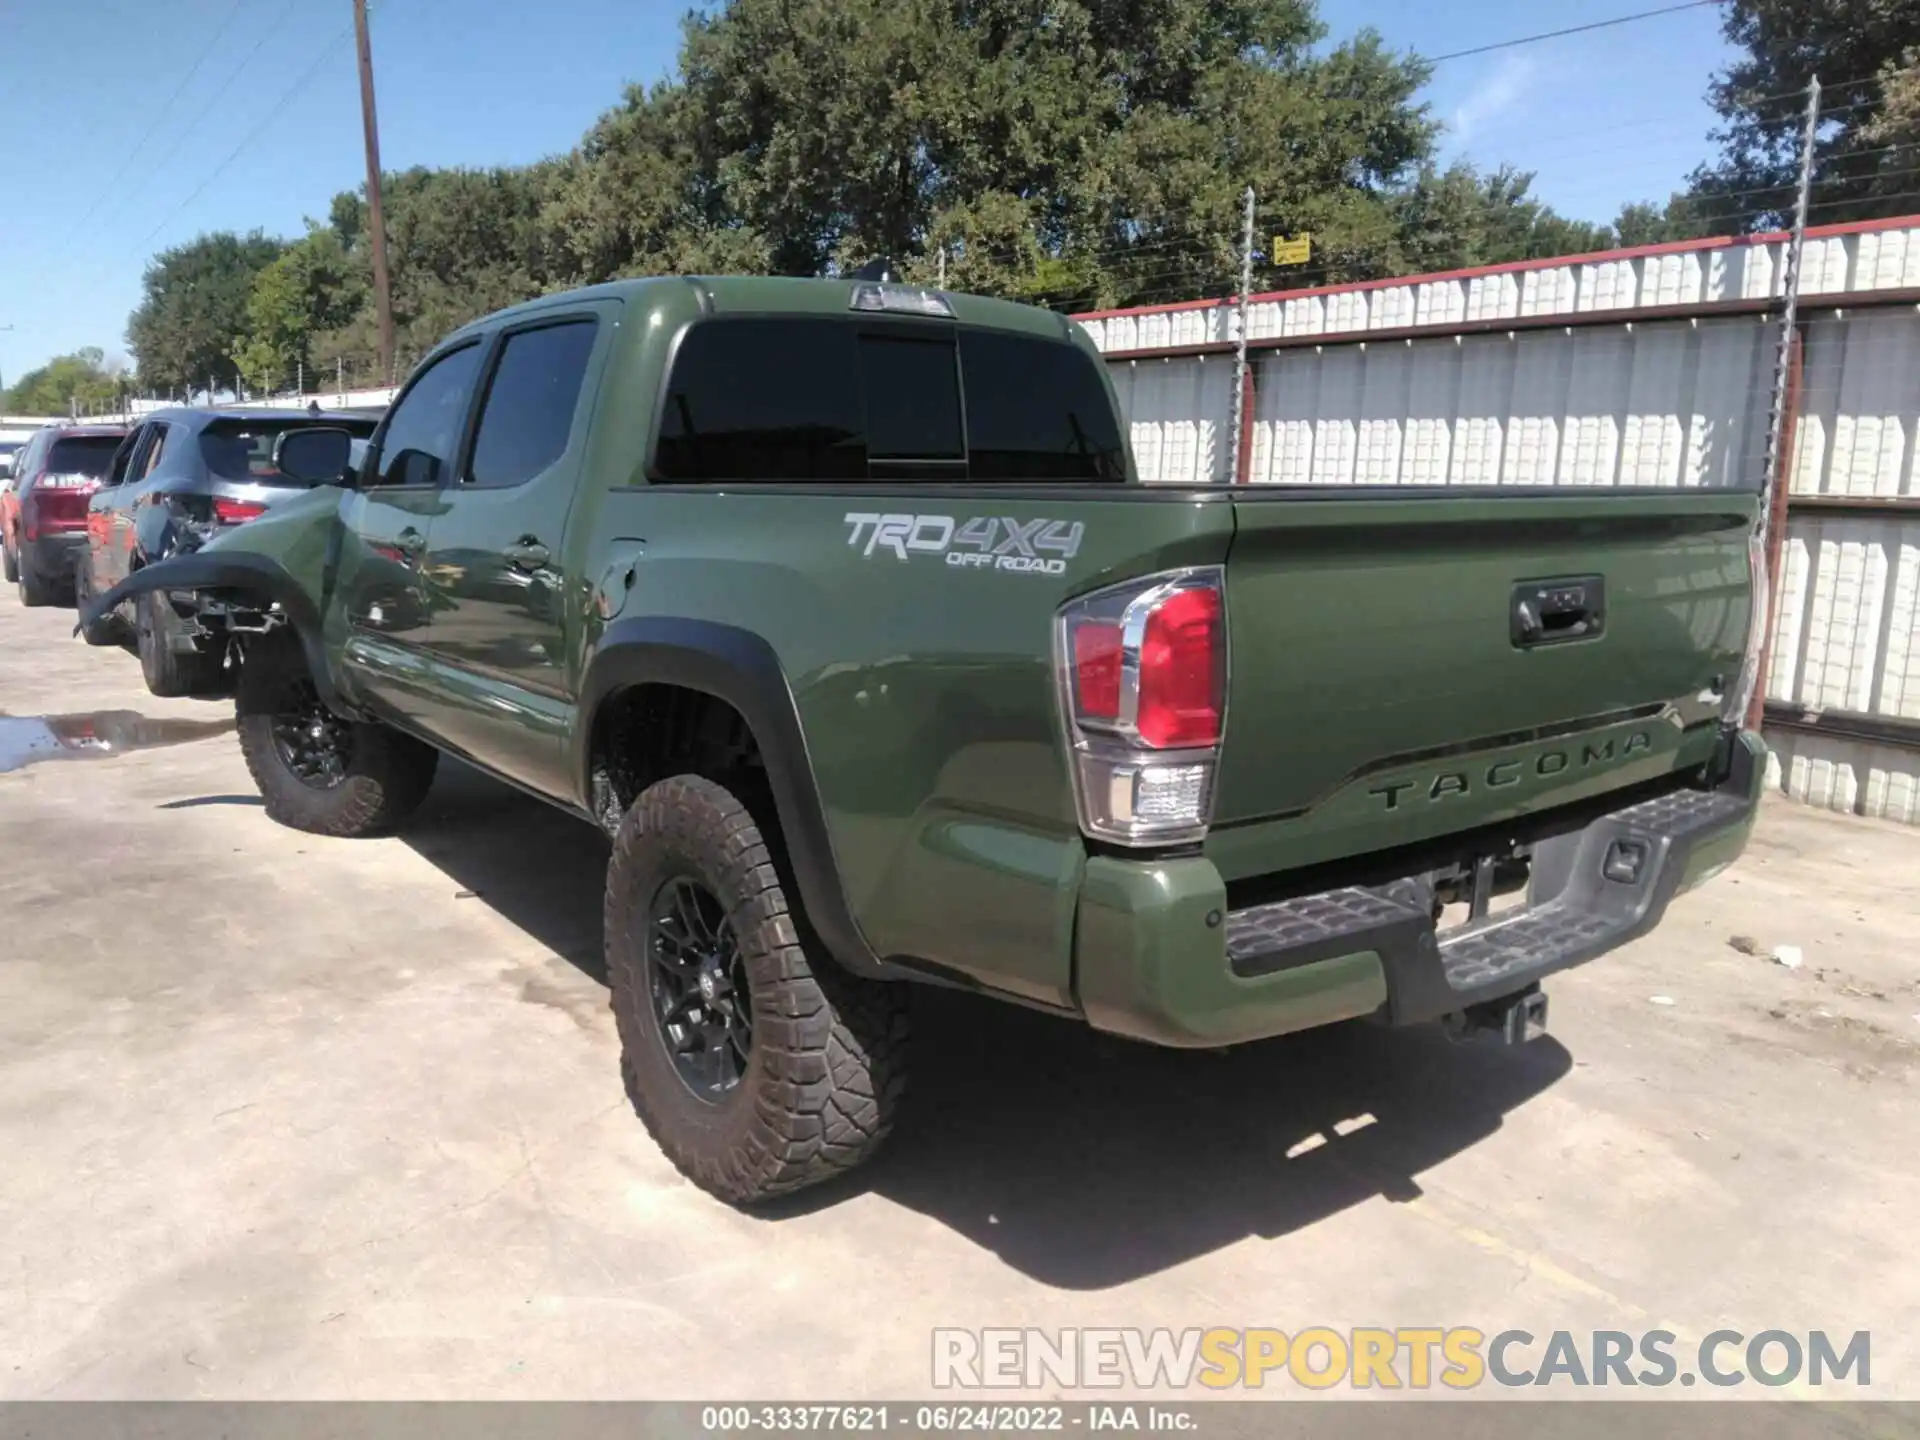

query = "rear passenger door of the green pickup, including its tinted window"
422;301;618;795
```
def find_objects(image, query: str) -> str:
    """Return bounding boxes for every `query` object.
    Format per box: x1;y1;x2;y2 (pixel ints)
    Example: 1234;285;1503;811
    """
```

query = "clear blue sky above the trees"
0;0;1726;378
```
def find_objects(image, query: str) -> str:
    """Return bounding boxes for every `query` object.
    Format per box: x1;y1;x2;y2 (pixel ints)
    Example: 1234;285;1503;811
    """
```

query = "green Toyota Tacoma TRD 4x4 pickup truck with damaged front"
83;278;1764;1204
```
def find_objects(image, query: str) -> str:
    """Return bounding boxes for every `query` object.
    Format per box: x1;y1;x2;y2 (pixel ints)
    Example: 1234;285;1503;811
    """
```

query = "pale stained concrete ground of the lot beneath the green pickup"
0;593;1920;1398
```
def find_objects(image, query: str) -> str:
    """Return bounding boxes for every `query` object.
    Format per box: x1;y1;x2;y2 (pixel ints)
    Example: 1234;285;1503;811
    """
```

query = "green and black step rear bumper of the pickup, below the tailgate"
1075;732;1766;1046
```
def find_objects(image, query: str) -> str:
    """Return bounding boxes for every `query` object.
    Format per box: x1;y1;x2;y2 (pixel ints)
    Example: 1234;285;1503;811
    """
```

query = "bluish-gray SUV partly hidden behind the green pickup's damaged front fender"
75;407;378;695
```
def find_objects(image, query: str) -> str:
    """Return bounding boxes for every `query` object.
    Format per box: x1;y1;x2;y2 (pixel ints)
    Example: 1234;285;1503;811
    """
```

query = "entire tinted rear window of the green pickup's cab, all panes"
653;317;1127;482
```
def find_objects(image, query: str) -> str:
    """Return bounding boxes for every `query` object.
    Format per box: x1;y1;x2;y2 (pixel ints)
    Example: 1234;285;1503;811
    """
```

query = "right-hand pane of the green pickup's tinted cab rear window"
960;330;1127;480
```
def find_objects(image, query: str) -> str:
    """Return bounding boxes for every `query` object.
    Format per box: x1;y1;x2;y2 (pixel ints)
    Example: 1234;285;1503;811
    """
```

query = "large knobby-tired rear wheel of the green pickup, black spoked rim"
605;776;906;1206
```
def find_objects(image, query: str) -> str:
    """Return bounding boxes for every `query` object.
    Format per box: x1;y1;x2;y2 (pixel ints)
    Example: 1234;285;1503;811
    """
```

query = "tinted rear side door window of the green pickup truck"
467;321;595;486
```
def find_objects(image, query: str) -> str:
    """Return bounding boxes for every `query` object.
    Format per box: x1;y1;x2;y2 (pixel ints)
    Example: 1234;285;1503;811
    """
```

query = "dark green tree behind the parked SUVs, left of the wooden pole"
127;230;284;390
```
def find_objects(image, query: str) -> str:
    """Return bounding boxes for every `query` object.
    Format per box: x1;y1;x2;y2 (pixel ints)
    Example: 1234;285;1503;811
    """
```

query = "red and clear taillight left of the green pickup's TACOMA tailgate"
1056;568;1227;845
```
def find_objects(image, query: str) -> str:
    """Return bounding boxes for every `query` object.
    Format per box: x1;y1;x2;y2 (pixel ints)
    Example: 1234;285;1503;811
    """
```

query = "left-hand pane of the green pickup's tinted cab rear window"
655;321;866;480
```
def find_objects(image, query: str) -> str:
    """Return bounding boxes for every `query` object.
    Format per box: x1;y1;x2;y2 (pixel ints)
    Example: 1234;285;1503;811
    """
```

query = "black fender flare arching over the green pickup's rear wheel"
574;614;898;979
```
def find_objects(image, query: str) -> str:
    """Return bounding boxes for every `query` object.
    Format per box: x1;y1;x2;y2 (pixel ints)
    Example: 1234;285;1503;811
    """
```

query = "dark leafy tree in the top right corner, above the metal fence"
1692;0;1920;232
